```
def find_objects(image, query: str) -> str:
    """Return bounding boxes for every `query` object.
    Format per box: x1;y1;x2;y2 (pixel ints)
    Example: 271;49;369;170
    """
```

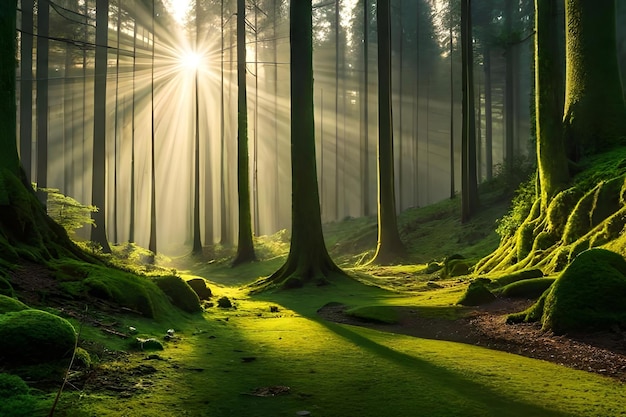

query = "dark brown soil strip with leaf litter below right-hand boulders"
318;299;626;381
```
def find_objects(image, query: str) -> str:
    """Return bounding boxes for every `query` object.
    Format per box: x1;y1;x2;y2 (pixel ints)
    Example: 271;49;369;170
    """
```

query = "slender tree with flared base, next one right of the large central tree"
371;0;406;264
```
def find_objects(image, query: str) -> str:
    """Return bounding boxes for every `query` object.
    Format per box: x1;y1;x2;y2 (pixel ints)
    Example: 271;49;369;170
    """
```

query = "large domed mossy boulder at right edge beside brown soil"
541;248;626;334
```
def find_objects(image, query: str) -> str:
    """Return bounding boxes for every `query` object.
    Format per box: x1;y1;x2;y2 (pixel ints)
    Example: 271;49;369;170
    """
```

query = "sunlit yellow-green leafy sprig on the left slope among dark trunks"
35;185;98;235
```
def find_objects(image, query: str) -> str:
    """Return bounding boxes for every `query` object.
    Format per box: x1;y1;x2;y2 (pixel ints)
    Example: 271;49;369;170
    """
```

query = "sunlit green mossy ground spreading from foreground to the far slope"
11;187;626;417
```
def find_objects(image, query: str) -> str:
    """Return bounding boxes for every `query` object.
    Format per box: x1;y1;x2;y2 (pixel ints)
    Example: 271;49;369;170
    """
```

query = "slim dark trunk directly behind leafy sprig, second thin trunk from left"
36;2;50;204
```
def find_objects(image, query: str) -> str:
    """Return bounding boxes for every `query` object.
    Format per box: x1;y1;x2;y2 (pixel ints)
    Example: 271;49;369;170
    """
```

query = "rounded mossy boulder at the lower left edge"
0;309;76;365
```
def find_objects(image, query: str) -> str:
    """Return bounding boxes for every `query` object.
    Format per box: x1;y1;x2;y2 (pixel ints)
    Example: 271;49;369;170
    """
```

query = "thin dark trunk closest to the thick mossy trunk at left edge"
19;0;34;181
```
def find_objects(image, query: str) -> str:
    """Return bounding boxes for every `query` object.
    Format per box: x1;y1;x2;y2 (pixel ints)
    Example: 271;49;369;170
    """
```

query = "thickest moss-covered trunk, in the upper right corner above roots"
563;0;626;160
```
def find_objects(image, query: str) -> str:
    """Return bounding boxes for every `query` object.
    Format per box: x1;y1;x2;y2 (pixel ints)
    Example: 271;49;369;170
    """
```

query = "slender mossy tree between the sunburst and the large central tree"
233;0;256;266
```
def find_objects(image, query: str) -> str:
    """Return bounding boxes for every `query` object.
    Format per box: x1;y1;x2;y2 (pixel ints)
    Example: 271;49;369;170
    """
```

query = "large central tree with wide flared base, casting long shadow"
257;0;342;288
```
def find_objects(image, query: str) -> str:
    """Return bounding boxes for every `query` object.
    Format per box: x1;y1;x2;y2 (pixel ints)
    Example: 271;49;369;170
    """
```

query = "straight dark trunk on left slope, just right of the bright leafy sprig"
91;0;111;253
